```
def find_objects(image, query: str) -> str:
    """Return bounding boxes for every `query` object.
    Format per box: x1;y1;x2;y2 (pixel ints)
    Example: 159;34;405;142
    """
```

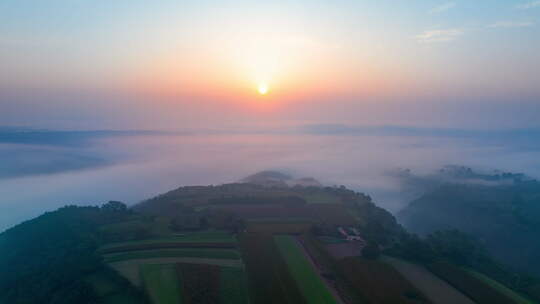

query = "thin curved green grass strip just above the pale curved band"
105;248;240;263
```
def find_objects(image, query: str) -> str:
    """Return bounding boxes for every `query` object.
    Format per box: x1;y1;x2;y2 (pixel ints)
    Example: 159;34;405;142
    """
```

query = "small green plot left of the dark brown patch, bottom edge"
140;264;182;304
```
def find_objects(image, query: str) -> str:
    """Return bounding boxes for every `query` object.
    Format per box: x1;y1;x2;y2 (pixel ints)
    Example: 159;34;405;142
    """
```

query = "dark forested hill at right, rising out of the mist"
398;167;540;275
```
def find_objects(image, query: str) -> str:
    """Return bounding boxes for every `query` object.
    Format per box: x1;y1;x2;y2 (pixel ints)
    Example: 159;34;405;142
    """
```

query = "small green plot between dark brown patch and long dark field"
219;267;249;304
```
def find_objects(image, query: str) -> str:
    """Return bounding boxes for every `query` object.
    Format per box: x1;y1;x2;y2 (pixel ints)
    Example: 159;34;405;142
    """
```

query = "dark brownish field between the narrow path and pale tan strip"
337;257;430;304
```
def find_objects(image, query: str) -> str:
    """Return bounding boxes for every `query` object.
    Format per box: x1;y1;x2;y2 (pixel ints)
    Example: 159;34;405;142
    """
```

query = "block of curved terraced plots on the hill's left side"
100;232;249;304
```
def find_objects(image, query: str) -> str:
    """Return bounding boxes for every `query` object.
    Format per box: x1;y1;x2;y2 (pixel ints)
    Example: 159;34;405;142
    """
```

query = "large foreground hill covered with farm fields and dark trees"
0;174;537;304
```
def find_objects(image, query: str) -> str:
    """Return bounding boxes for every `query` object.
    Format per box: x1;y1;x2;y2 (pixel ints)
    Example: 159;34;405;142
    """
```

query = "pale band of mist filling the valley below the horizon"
0;126;540;231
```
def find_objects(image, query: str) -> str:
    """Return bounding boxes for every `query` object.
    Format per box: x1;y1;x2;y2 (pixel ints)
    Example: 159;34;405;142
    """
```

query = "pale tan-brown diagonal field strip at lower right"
383;257;474;304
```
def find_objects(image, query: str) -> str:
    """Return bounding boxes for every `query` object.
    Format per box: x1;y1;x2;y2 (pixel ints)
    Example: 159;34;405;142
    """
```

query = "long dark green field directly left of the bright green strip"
239;233;306;304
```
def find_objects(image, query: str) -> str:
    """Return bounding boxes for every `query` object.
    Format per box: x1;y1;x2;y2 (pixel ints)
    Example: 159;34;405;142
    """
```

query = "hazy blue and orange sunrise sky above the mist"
0;0;540;130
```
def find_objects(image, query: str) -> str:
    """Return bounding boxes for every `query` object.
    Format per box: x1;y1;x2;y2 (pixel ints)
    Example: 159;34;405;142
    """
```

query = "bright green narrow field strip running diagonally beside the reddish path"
274;235;337;304
